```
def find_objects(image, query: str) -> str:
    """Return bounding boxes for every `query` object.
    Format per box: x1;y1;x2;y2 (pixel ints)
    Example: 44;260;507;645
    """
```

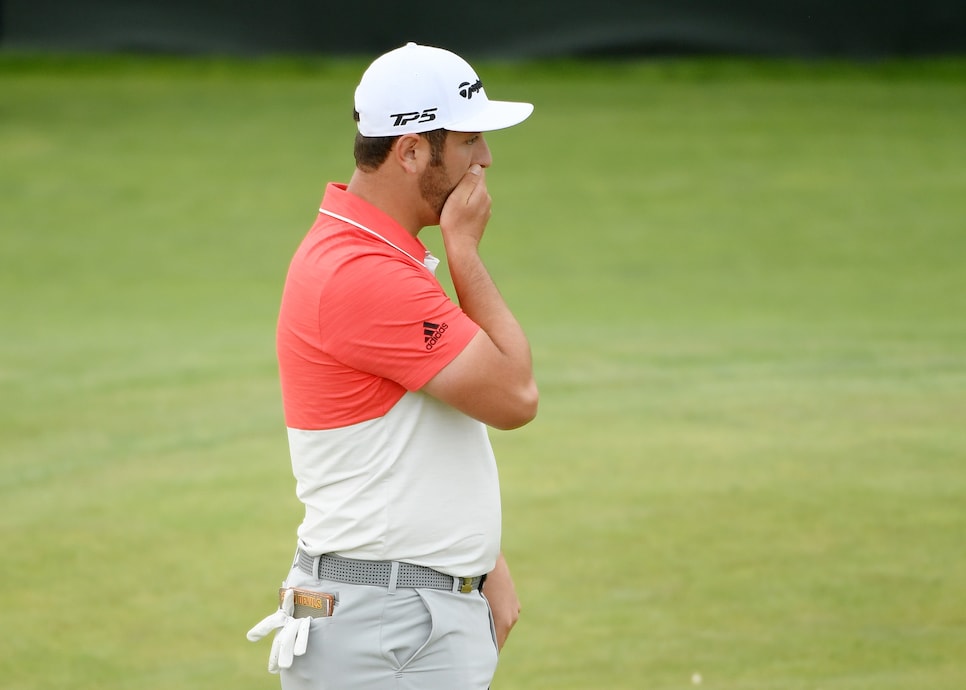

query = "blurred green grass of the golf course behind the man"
0;56;966;690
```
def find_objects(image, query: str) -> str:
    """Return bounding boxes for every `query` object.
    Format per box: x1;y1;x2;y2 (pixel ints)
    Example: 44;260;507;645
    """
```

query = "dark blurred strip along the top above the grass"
0;0;966;58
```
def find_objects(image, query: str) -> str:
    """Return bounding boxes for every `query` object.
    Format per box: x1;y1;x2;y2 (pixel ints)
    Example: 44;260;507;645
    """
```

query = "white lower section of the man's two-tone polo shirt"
288;392;501;577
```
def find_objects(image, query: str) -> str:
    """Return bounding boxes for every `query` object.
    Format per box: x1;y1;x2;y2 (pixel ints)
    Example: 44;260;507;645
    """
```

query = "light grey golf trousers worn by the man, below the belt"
281;567;497;690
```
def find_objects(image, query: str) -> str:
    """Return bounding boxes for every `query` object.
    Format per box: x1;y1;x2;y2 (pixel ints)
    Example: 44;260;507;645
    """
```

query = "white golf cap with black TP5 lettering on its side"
355;43;533;137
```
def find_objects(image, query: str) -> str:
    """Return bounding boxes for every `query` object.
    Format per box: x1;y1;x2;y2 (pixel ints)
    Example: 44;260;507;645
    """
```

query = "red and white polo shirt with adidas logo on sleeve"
277;184;500;577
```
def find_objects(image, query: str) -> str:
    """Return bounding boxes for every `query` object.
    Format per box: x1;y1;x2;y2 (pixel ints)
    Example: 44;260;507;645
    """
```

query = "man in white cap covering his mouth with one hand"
249;43;538;690
